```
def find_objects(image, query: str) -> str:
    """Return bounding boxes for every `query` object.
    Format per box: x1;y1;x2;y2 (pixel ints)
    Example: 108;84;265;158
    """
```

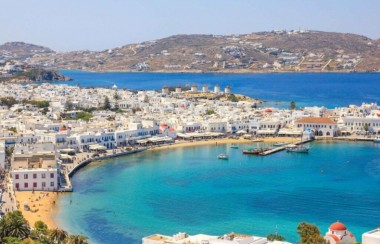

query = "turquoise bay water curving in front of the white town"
56;142;380;243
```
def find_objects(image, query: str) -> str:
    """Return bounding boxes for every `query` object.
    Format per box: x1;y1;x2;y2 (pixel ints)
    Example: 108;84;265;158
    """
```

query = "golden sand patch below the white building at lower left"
15;191;58;228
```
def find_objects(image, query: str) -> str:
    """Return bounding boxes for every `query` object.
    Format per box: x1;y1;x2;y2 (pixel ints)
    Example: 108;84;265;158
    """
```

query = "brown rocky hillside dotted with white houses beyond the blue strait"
0;31;380;73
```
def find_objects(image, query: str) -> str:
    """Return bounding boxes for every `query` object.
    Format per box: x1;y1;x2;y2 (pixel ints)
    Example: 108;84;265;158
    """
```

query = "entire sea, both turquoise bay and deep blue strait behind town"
55;71;380;243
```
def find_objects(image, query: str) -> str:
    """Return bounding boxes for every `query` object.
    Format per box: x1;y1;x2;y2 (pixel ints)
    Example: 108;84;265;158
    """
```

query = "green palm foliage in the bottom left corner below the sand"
0;211;88;244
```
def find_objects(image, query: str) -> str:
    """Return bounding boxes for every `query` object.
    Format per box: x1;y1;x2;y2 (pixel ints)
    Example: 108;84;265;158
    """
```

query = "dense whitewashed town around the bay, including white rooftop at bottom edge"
0;83;380;243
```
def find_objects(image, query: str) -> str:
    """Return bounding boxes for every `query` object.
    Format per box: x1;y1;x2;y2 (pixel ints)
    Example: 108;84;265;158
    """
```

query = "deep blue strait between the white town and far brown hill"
58;70;380;108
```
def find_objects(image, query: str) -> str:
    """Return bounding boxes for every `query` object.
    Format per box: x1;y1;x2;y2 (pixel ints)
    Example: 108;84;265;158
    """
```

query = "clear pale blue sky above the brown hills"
0;0;380;51
